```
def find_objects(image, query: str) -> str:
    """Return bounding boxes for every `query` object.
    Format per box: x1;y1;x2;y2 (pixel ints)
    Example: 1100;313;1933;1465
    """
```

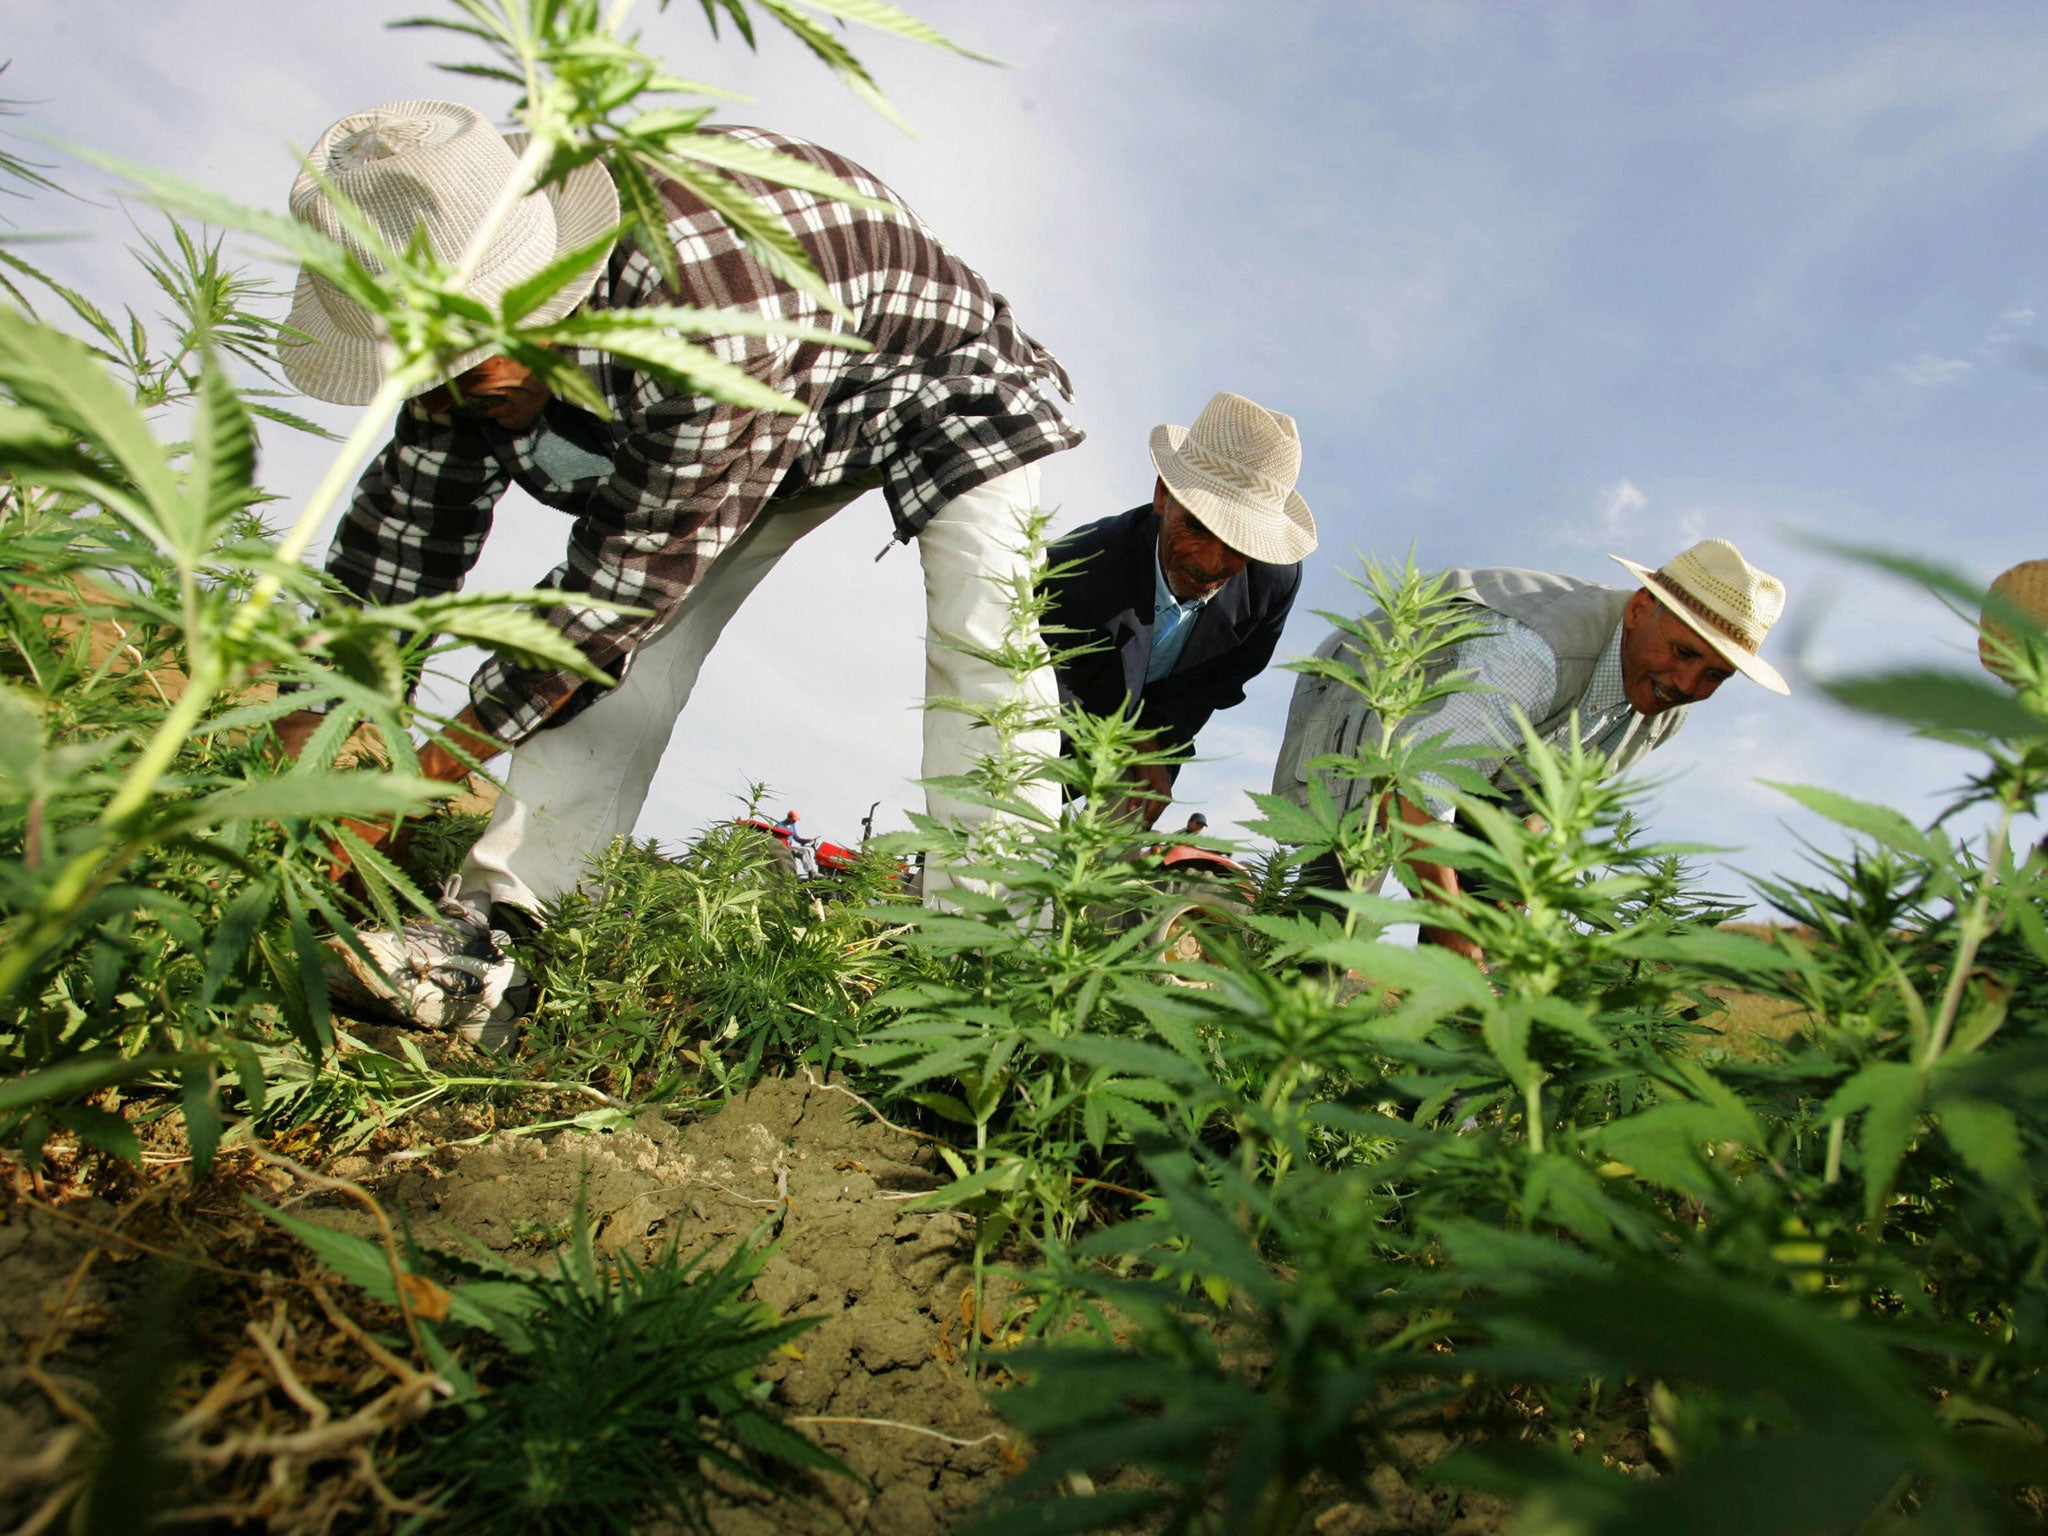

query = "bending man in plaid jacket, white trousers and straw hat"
281;102;1081;946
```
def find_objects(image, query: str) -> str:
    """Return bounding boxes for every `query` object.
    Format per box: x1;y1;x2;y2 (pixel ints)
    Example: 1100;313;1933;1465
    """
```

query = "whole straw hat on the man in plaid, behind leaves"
276;100;618;406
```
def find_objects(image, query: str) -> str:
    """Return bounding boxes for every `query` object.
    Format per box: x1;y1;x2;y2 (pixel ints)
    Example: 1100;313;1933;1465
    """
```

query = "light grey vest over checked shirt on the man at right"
1274;565;1688;809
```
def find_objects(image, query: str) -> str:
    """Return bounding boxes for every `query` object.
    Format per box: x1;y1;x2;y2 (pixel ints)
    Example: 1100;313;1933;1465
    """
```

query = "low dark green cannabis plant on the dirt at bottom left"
264;1200;846;1536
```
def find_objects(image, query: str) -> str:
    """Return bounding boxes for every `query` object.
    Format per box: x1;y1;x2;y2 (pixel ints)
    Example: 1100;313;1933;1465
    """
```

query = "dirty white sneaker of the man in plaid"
322;874;528;1047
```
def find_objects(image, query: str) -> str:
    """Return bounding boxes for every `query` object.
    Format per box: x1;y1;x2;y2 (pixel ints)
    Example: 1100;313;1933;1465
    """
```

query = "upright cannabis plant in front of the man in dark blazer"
848;518;1227;1257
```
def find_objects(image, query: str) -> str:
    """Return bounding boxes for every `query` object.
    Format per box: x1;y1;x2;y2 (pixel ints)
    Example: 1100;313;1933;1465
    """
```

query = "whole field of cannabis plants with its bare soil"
0;0;2048;1536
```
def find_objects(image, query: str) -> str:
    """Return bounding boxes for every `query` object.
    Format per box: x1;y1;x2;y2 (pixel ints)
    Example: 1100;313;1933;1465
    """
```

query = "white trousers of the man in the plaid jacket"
461;465;1059;911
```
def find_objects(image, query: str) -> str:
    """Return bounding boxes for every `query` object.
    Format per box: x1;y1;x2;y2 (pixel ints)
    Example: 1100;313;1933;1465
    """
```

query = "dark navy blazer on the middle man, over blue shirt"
1044;502;1300;774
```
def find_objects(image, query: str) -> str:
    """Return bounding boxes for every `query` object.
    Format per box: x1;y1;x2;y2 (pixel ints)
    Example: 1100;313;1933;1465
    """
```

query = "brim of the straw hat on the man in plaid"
279;133;618;406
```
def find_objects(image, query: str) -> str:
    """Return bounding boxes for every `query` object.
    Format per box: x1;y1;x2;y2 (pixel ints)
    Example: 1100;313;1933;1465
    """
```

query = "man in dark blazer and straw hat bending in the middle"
1044;393;1315;827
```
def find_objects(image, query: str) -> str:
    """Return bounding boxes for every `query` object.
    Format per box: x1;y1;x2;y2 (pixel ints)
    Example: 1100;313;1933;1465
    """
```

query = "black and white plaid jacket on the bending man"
328;129;1081;743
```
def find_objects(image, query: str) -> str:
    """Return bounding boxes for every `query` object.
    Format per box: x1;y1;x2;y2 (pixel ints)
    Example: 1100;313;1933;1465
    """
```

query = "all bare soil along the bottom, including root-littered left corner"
0;1077;1507;1536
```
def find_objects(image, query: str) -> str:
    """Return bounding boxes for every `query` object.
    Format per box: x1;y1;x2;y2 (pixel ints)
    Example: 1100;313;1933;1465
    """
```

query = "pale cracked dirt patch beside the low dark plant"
378;1079;1004;1536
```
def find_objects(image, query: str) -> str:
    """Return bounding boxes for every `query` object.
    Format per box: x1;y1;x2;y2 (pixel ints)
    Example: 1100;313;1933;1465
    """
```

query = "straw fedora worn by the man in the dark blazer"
1151;393;1315;565
